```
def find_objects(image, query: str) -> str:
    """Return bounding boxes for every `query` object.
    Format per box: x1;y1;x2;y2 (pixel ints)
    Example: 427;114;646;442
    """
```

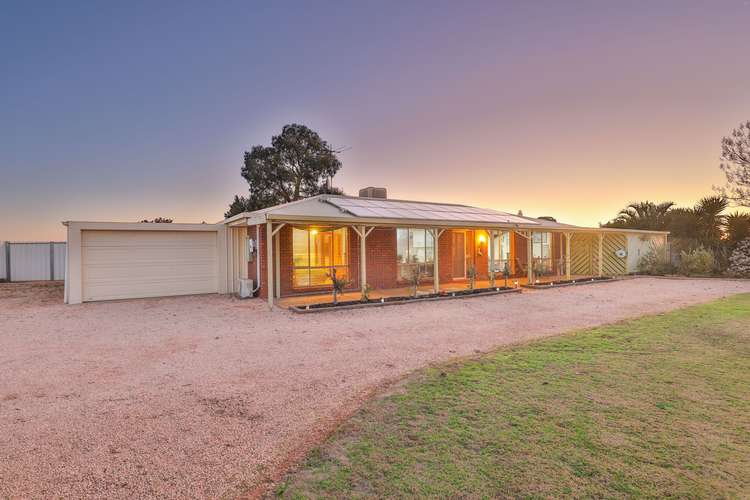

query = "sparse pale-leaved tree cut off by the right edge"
719;120;750;207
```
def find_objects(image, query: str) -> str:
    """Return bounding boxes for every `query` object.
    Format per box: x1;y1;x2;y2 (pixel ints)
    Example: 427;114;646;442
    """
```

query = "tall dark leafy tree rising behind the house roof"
225;123;342;217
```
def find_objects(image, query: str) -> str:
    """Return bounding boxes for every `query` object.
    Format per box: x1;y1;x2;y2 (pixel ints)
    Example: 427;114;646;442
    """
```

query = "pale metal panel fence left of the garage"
0;241;65;281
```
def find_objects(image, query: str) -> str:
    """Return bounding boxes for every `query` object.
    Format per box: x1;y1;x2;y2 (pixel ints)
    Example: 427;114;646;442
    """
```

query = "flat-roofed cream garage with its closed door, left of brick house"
65;223;225;303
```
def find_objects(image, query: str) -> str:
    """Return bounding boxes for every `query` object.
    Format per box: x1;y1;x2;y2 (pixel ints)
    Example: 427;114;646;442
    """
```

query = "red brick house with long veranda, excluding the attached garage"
223;188;666;305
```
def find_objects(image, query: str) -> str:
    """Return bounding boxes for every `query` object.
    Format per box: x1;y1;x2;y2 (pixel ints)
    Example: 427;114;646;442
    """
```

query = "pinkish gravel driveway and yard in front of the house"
0;278;750;498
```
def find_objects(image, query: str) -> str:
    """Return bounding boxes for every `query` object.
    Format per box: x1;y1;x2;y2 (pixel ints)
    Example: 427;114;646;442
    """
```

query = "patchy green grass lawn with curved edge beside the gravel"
277;295;750;498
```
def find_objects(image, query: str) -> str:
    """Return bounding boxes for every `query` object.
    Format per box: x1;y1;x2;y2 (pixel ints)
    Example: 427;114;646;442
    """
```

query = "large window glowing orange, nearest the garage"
292;227;349;288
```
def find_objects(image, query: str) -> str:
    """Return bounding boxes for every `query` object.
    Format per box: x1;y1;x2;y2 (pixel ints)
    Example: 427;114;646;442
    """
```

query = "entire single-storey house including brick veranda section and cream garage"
64;188;667;305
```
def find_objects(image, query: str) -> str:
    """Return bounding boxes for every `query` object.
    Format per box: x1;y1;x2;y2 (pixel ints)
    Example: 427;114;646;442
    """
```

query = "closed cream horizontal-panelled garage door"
81;231;218;301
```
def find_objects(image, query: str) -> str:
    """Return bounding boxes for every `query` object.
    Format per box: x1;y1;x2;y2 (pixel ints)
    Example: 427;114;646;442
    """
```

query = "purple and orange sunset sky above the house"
0;0;750;241
